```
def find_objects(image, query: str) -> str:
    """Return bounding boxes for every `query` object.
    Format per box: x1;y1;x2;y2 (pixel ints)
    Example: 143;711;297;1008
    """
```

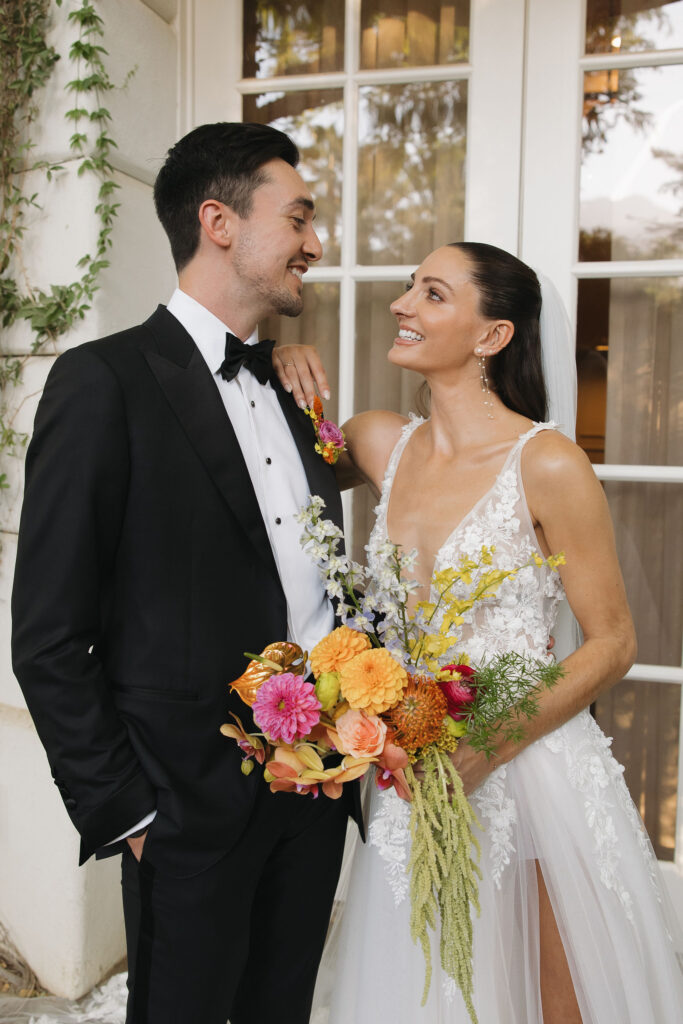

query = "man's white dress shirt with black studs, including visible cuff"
108;288;334;845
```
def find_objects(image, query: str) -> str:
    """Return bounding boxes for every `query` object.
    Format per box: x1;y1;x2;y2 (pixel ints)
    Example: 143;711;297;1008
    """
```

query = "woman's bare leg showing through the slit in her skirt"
536;861;582;1024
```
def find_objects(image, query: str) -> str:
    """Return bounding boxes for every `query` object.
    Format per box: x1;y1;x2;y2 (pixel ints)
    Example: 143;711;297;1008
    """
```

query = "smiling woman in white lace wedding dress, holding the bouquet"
278;244;683;1024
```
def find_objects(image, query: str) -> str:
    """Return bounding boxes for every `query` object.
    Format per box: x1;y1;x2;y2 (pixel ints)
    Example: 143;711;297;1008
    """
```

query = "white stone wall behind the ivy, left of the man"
0;0;179;997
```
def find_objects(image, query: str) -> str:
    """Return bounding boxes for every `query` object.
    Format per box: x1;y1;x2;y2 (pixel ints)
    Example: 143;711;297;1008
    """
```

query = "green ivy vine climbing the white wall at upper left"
0;0;126;488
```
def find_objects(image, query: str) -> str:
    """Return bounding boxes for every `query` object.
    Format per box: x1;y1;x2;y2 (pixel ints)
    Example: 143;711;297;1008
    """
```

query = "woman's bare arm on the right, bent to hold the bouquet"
453;432;636;793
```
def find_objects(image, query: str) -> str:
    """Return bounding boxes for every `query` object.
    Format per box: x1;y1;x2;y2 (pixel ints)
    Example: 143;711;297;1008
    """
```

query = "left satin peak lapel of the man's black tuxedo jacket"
144;310;280;580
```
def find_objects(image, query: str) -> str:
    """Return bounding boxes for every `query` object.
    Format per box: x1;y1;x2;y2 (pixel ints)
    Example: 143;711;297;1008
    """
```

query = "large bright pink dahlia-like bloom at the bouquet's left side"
252;672;322;743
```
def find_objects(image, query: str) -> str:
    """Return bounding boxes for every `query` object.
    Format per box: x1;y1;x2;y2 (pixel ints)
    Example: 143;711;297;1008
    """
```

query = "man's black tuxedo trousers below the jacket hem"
122;785;348;1024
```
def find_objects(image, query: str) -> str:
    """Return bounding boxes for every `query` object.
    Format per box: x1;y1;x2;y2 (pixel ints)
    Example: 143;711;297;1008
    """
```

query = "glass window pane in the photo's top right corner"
586;0;683;53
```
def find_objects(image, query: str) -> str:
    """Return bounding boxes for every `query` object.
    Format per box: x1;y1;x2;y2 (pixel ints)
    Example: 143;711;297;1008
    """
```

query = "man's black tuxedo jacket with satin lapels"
12;306;358;874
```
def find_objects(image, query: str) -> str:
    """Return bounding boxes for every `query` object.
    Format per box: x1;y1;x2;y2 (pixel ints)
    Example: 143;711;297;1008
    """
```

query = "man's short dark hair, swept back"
155;121;299;270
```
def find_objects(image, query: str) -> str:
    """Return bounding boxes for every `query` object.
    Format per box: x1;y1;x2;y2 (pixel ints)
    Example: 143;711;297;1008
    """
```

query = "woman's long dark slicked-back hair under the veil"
451;242;548;421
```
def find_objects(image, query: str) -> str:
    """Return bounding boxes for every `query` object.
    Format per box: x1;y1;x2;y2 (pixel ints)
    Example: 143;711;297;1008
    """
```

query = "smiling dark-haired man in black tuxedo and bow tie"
12;124;358;1024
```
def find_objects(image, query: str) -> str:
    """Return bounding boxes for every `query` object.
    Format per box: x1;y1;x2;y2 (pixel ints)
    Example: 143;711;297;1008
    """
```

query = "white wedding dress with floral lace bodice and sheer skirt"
321;418;683;1024
